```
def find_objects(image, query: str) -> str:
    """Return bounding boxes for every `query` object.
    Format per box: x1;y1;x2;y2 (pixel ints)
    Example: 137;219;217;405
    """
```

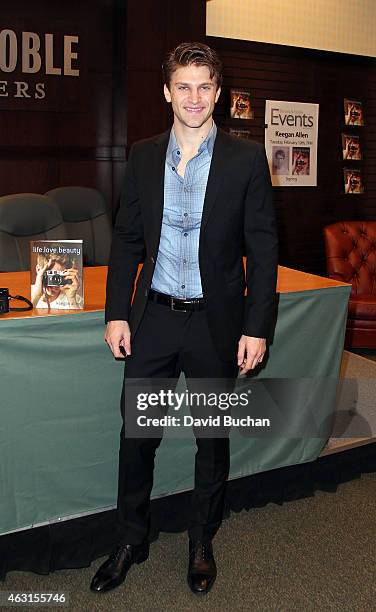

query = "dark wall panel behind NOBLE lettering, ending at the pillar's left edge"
0;0;126;215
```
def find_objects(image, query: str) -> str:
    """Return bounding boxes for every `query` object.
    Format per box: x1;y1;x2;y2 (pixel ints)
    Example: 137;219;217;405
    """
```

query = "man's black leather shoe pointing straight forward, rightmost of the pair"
187;542;217;595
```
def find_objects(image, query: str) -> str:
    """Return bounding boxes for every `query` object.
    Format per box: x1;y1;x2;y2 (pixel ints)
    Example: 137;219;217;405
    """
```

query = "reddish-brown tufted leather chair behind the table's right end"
324;221;376;348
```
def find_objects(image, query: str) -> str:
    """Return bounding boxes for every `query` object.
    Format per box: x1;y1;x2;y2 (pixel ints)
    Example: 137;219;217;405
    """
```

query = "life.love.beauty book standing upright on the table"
30;240;84;310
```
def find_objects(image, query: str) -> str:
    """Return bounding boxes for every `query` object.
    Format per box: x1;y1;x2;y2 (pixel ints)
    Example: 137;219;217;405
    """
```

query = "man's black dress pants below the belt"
118;301;238;545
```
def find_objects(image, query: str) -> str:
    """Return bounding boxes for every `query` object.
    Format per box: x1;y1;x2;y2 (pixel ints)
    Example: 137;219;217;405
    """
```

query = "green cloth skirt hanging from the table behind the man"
0;286;350;534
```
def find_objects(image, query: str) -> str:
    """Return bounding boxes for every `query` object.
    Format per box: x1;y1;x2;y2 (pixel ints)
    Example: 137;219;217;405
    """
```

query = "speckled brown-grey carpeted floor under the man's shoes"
0;354;376;612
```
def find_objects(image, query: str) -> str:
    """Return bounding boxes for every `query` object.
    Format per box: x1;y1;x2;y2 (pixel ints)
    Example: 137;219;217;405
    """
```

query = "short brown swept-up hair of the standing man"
162;42;223;88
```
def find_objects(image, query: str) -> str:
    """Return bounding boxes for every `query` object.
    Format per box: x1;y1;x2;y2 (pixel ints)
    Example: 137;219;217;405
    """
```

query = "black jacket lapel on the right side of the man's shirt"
201;129;232;232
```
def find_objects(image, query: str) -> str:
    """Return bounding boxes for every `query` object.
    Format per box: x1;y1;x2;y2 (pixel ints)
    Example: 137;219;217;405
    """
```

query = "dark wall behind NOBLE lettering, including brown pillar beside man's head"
0;0;206;213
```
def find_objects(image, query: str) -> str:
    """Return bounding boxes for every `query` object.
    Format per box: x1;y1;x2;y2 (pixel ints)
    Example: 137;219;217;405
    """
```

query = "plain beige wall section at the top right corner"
206;0;376;57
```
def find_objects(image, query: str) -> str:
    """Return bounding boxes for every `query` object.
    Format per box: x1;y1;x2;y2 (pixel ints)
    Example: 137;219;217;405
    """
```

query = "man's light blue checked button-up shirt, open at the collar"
151;123;217;299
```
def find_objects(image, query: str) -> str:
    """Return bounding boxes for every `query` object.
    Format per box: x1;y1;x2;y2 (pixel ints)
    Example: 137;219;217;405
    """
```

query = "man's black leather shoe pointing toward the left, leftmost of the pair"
90;544;149;593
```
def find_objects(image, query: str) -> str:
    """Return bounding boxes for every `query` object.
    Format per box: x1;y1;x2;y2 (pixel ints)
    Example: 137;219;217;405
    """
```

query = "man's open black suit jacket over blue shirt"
106;129;277;360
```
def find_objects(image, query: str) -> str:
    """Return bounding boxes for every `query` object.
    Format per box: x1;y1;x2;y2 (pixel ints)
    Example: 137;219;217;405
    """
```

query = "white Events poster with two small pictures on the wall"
265;100;319;187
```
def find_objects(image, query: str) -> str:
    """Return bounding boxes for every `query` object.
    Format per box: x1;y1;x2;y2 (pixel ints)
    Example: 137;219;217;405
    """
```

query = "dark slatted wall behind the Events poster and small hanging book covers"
207;37;376;274
